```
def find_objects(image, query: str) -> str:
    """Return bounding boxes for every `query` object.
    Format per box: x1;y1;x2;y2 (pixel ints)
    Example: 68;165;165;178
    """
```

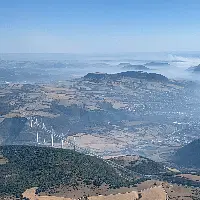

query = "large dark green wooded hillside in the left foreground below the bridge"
0;146;130;196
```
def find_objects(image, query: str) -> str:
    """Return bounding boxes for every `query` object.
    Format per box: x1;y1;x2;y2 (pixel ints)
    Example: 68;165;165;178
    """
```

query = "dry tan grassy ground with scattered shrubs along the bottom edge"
23;180;200;200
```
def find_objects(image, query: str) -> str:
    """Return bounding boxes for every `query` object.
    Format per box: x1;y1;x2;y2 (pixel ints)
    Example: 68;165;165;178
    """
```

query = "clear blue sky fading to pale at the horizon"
0;0;200;54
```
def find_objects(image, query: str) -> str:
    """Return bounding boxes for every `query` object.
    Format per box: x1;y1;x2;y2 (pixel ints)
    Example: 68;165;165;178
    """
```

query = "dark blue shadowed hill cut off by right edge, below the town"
173;139;200;169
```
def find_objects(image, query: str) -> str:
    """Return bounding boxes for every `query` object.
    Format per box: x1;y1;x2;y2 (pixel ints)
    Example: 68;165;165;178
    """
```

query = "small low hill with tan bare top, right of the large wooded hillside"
110;155;166;175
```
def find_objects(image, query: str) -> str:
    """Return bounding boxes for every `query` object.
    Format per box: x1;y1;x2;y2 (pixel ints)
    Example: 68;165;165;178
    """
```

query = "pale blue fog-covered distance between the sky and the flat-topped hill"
0;53;200;83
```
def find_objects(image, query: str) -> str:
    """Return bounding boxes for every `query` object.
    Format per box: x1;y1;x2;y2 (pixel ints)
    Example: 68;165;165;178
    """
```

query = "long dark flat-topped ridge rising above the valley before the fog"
84;71;168;82
